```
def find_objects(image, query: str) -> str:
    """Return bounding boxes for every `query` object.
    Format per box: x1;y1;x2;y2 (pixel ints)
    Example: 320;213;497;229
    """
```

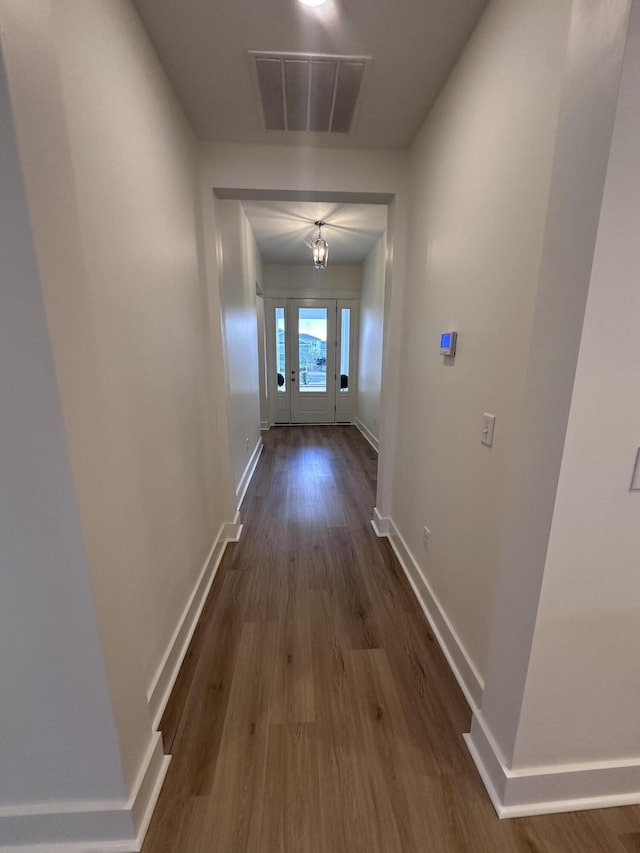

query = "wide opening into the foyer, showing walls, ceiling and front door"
213;188;400;502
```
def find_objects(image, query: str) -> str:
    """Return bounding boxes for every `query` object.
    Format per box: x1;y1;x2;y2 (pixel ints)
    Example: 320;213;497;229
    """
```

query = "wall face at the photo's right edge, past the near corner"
514;3;640;766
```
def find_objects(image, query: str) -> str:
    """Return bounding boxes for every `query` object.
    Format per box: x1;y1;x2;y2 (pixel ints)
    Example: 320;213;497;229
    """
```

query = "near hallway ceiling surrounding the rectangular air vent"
134;0;486;148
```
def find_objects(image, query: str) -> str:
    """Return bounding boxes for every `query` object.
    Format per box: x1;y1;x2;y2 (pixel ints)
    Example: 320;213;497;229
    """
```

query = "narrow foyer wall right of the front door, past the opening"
358;234;387;440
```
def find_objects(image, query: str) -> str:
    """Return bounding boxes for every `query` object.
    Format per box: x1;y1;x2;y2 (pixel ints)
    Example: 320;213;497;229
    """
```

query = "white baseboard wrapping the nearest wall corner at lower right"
464;711;640;818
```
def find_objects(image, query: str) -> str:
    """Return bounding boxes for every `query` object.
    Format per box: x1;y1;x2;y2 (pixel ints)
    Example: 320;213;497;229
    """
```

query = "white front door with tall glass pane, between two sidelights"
288;299;336;424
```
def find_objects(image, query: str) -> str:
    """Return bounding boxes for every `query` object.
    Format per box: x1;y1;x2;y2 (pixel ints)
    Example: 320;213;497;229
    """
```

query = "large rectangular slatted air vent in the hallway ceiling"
249;51;370;133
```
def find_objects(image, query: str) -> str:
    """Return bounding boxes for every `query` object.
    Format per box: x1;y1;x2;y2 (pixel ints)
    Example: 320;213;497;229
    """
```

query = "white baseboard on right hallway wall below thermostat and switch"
372;508;484;711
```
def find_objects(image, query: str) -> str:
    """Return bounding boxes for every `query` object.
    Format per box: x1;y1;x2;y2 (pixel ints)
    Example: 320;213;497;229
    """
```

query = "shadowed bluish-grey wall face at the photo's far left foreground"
0;30;125;808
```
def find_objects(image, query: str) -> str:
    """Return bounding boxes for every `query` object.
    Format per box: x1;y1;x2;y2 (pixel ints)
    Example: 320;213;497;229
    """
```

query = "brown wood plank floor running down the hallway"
143;427;640;853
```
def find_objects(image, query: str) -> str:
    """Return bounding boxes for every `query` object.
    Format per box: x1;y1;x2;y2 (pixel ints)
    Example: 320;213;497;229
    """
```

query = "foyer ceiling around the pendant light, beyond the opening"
243;201;387;265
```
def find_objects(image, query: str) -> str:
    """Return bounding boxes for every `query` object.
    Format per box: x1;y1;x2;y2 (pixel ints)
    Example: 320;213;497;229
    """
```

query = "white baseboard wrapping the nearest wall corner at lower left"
0;732;171;853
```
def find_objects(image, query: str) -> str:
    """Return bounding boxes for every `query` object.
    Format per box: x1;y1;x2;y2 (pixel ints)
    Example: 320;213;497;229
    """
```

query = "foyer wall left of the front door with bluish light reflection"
216;200;262;497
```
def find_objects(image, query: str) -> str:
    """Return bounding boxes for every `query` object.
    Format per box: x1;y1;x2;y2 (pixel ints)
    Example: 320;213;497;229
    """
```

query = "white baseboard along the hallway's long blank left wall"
147;515;242;731
